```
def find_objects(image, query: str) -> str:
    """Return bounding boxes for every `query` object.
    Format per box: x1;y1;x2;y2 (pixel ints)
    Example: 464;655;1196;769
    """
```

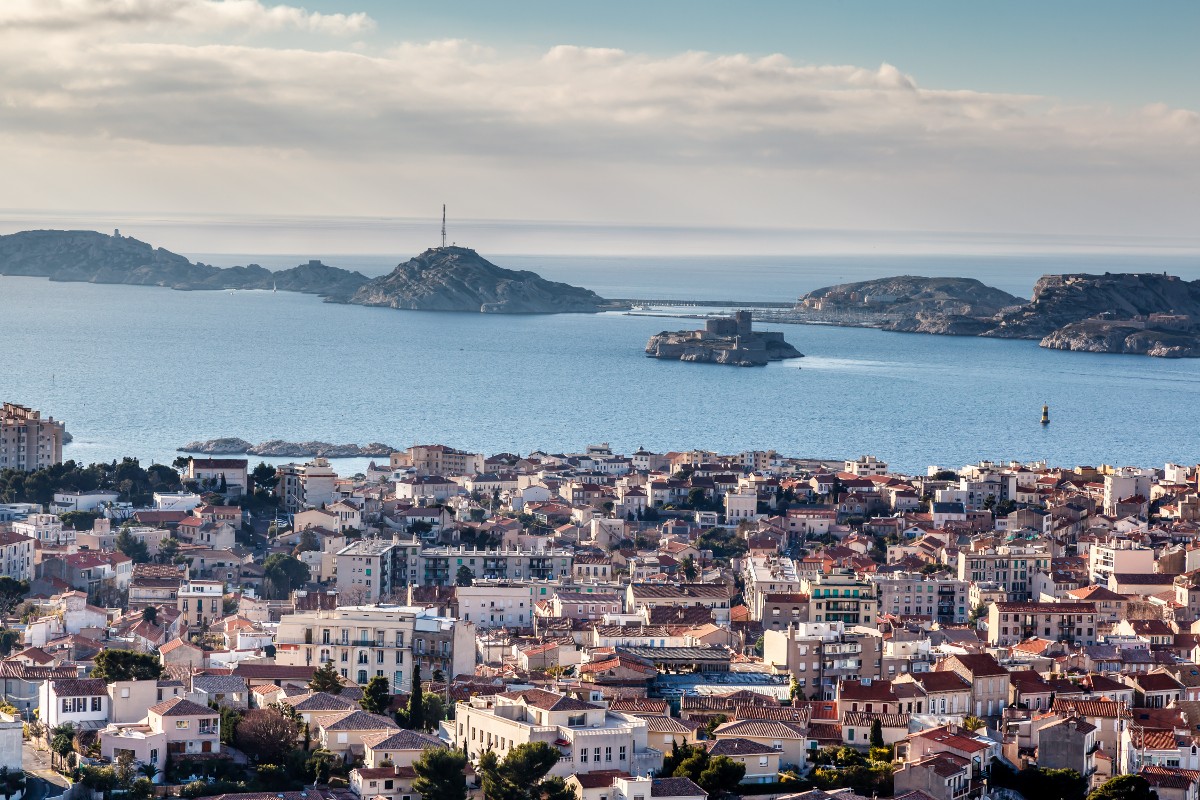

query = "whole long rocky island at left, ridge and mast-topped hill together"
0;230;620;314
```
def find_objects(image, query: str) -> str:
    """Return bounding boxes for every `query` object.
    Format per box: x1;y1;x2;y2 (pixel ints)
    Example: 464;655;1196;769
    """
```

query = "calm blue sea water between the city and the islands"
0;258;1200;470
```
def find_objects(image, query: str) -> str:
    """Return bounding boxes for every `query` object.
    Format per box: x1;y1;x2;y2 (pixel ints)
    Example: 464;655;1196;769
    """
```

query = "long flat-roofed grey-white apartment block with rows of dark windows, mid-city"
418;545;575;587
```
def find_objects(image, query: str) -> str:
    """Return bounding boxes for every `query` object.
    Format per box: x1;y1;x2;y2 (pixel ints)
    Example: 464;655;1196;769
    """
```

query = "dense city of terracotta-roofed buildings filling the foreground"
0;403;1200;800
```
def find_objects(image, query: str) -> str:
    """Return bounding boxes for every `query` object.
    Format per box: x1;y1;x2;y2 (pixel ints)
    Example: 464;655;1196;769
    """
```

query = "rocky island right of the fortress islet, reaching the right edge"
792;272;1200;359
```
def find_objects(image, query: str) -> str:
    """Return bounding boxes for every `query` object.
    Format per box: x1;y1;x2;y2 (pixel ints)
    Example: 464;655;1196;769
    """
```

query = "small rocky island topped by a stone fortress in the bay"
646;311;804;367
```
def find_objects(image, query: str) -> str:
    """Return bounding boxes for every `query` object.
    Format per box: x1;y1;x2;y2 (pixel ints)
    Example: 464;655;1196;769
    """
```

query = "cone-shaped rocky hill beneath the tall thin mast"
350;247;606;314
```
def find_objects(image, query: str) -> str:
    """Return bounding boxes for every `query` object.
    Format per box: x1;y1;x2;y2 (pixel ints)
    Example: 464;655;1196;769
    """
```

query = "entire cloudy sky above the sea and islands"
0;0;1200;252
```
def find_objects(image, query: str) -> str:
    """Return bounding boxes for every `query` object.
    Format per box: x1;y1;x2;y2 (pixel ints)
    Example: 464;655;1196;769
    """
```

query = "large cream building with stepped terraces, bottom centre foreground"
444;688;662;777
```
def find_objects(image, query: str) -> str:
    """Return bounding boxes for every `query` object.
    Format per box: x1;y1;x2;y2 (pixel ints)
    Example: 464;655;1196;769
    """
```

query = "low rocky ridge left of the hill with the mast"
0;230;367;300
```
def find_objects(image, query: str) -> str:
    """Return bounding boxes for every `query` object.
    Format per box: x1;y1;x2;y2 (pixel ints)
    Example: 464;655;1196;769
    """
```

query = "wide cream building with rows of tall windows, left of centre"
275;604;475;692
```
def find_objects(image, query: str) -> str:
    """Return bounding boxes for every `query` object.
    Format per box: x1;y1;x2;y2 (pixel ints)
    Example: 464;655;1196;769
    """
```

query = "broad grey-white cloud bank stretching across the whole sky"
0;11;1200;237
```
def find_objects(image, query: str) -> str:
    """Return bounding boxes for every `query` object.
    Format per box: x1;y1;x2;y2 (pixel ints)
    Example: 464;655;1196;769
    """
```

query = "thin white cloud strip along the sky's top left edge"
0;0;374;36
